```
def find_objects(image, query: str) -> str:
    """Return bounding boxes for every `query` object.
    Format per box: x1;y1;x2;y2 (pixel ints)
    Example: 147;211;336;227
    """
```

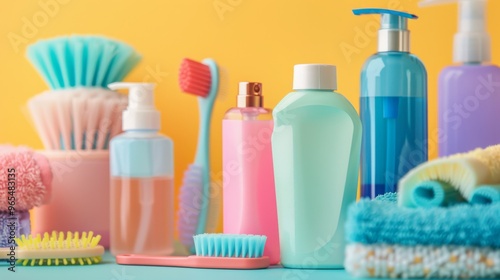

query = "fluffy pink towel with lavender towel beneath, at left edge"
0;146;52;248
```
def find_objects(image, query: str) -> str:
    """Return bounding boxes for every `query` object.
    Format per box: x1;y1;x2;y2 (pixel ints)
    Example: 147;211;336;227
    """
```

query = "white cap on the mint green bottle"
293;64;337;90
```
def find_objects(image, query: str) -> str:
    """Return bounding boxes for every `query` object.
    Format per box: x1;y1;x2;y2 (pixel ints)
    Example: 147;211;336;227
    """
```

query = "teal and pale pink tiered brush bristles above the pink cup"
26;35;141;150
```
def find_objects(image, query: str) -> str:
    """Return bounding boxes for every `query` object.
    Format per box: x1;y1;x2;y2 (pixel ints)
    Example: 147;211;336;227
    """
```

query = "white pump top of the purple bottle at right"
419;0;491;64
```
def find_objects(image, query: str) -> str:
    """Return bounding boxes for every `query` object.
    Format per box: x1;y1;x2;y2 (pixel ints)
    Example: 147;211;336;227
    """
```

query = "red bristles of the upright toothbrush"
179;58;212;97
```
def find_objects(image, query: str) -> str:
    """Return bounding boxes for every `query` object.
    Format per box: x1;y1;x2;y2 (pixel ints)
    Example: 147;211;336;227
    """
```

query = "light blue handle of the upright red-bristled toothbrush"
194;59;219;237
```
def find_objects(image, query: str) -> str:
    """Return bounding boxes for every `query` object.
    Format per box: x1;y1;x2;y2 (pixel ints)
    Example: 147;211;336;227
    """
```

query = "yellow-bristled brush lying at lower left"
0;231;104;266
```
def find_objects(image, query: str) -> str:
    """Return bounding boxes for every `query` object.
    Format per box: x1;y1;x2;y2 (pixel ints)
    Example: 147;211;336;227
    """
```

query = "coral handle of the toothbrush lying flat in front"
116;255;269;269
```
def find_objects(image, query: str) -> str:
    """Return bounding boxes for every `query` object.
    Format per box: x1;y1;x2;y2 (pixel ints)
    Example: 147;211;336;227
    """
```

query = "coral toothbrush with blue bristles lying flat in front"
116;234;269;269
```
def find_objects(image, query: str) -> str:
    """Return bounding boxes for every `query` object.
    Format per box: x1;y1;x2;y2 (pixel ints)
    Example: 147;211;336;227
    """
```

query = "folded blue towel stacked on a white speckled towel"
345;193;500;278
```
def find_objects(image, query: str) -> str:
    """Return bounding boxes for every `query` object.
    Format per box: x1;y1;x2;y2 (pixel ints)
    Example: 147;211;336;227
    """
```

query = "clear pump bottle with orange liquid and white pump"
108;83;174;255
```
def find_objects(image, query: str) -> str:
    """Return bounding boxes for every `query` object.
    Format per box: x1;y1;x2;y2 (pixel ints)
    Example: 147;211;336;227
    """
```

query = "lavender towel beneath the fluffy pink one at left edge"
0;211;31;247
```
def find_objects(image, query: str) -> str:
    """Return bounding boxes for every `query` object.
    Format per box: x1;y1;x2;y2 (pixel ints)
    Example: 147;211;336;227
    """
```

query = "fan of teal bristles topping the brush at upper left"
26;35;141;89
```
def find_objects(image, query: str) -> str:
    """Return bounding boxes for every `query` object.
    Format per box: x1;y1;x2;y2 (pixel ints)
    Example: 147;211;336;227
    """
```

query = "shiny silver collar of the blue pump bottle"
378;29;410;53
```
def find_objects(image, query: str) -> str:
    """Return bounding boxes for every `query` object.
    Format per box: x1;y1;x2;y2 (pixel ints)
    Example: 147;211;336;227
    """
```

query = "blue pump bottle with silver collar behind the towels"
354;9;428;198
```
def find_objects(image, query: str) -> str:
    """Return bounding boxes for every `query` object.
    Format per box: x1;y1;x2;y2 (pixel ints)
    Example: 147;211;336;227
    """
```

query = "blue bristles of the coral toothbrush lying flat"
193;233;267;258
